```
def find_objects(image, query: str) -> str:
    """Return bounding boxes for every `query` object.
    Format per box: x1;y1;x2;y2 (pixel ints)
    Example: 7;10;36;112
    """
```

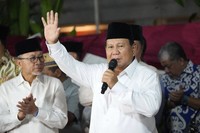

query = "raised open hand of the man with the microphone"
41;10;60;44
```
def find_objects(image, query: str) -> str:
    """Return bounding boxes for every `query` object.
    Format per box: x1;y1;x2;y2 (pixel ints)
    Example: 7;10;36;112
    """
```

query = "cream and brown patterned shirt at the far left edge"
0;51;19;84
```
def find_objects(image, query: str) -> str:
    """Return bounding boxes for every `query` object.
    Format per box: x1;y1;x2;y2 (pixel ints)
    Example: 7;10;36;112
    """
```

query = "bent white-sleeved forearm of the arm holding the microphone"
112;83;161;117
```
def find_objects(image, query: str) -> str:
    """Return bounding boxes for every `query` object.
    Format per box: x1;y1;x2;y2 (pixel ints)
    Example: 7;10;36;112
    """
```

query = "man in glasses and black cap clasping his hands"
0;38;68;133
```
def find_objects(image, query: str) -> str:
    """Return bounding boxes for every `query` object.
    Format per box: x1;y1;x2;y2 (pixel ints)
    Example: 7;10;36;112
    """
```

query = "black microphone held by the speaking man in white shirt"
101;59;117;94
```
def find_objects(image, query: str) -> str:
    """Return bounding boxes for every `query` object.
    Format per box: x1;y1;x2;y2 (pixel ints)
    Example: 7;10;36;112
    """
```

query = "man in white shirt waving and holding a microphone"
42;11;161;133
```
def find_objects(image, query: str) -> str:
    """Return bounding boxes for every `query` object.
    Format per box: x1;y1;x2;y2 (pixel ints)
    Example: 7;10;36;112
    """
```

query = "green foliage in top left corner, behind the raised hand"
0;0;64;36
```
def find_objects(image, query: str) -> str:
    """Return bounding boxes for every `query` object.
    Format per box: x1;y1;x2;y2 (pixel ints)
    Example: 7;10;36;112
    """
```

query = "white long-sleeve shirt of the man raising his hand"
47;42;161;133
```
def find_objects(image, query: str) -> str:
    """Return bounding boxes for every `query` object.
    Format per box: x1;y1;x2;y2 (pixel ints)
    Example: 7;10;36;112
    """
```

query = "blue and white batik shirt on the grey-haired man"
161;61;200;133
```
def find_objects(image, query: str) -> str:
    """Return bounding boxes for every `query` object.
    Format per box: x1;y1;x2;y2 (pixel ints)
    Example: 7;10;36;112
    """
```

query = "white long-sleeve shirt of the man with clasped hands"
0;74;68;133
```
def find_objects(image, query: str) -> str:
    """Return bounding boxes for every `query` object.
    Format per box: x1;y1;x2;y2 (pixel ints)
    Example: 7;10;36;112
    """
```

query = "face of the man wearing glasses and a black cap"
17;51;44;76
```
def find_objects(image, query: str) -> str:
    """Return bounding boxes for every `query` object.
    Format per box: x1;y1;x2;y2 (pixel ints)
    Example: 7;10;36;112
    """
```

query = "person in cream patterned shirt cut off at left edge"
0;25;19;85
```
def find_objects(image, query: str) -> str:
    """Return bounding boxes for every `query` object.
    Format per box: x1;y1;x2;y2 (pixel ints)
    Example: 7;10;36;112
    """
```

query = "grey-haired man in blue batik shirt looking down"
158;42;200;133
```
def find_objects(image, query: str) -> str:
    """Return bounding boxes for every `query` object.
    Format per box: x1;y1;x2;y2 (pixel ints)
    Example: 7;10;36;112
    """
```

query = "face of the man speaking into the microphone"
106;39;135;70
